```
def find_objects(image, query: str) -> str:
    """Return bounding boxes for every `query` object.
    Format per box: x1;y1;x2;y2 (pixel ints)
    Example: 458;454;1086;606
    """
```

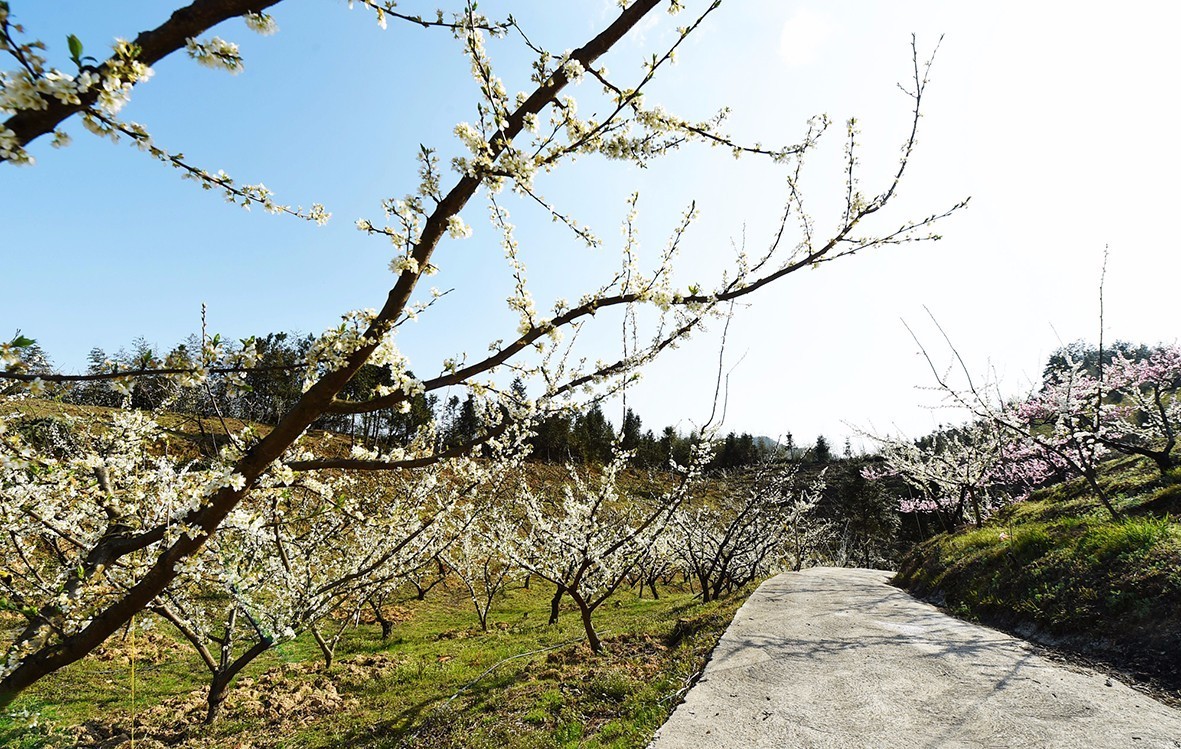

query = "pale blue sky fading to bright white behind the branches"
0;0;1181;441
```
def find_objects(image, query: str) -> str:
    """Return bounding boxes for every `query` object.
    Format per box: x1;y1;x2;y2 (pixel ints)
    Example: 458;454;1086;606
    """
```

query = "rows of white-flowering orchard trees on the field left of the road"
0;394;833;722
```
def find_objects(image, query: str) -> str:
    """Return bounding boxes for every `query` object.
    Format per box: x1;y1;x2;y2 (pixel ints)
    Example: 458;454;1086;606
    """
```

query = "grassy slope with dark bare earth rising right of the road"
895;458;1181;697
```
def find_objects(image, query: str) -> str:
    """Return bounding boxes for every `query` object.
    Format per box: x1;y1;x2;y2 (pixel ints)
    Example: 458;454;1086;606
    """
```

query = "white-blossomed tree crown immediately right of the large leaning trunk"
158;418;531;699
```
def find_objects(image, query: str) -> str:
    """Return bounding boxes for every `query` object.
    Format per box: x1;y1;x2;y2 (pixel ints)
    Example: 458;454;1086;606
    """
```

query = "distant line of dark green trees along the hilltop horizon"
11;333;831;469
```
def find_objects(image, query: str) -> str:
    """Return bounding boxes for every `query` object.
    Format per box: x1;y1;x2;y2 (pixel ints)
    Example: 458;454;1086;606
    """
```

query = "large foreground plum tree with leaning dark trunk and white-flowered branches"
0;0;964;705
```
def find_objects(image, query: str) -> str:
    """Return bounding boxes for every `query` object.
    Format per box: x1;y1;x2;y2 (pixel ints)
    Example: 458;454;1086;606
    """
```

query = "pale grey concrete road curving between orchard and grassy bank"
650;568;1181;749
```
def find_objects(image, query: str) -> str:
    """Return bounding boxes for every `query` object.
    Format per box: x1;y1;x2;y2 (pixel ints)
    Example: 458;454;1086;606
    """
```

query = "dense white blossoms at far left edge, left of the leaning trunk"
0;411;242;673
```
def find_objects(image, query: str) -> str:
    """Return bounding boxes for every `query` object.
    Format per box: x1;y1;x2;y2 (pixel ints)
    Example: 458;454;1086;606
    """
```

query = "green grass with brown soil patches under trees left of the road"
0;576;749;749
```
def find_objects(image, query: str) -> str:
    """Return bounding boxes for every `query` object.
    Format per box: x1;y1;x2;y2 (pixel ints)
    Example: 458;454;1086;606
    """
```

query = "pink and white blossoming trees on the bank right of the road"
866;344;1181;525
